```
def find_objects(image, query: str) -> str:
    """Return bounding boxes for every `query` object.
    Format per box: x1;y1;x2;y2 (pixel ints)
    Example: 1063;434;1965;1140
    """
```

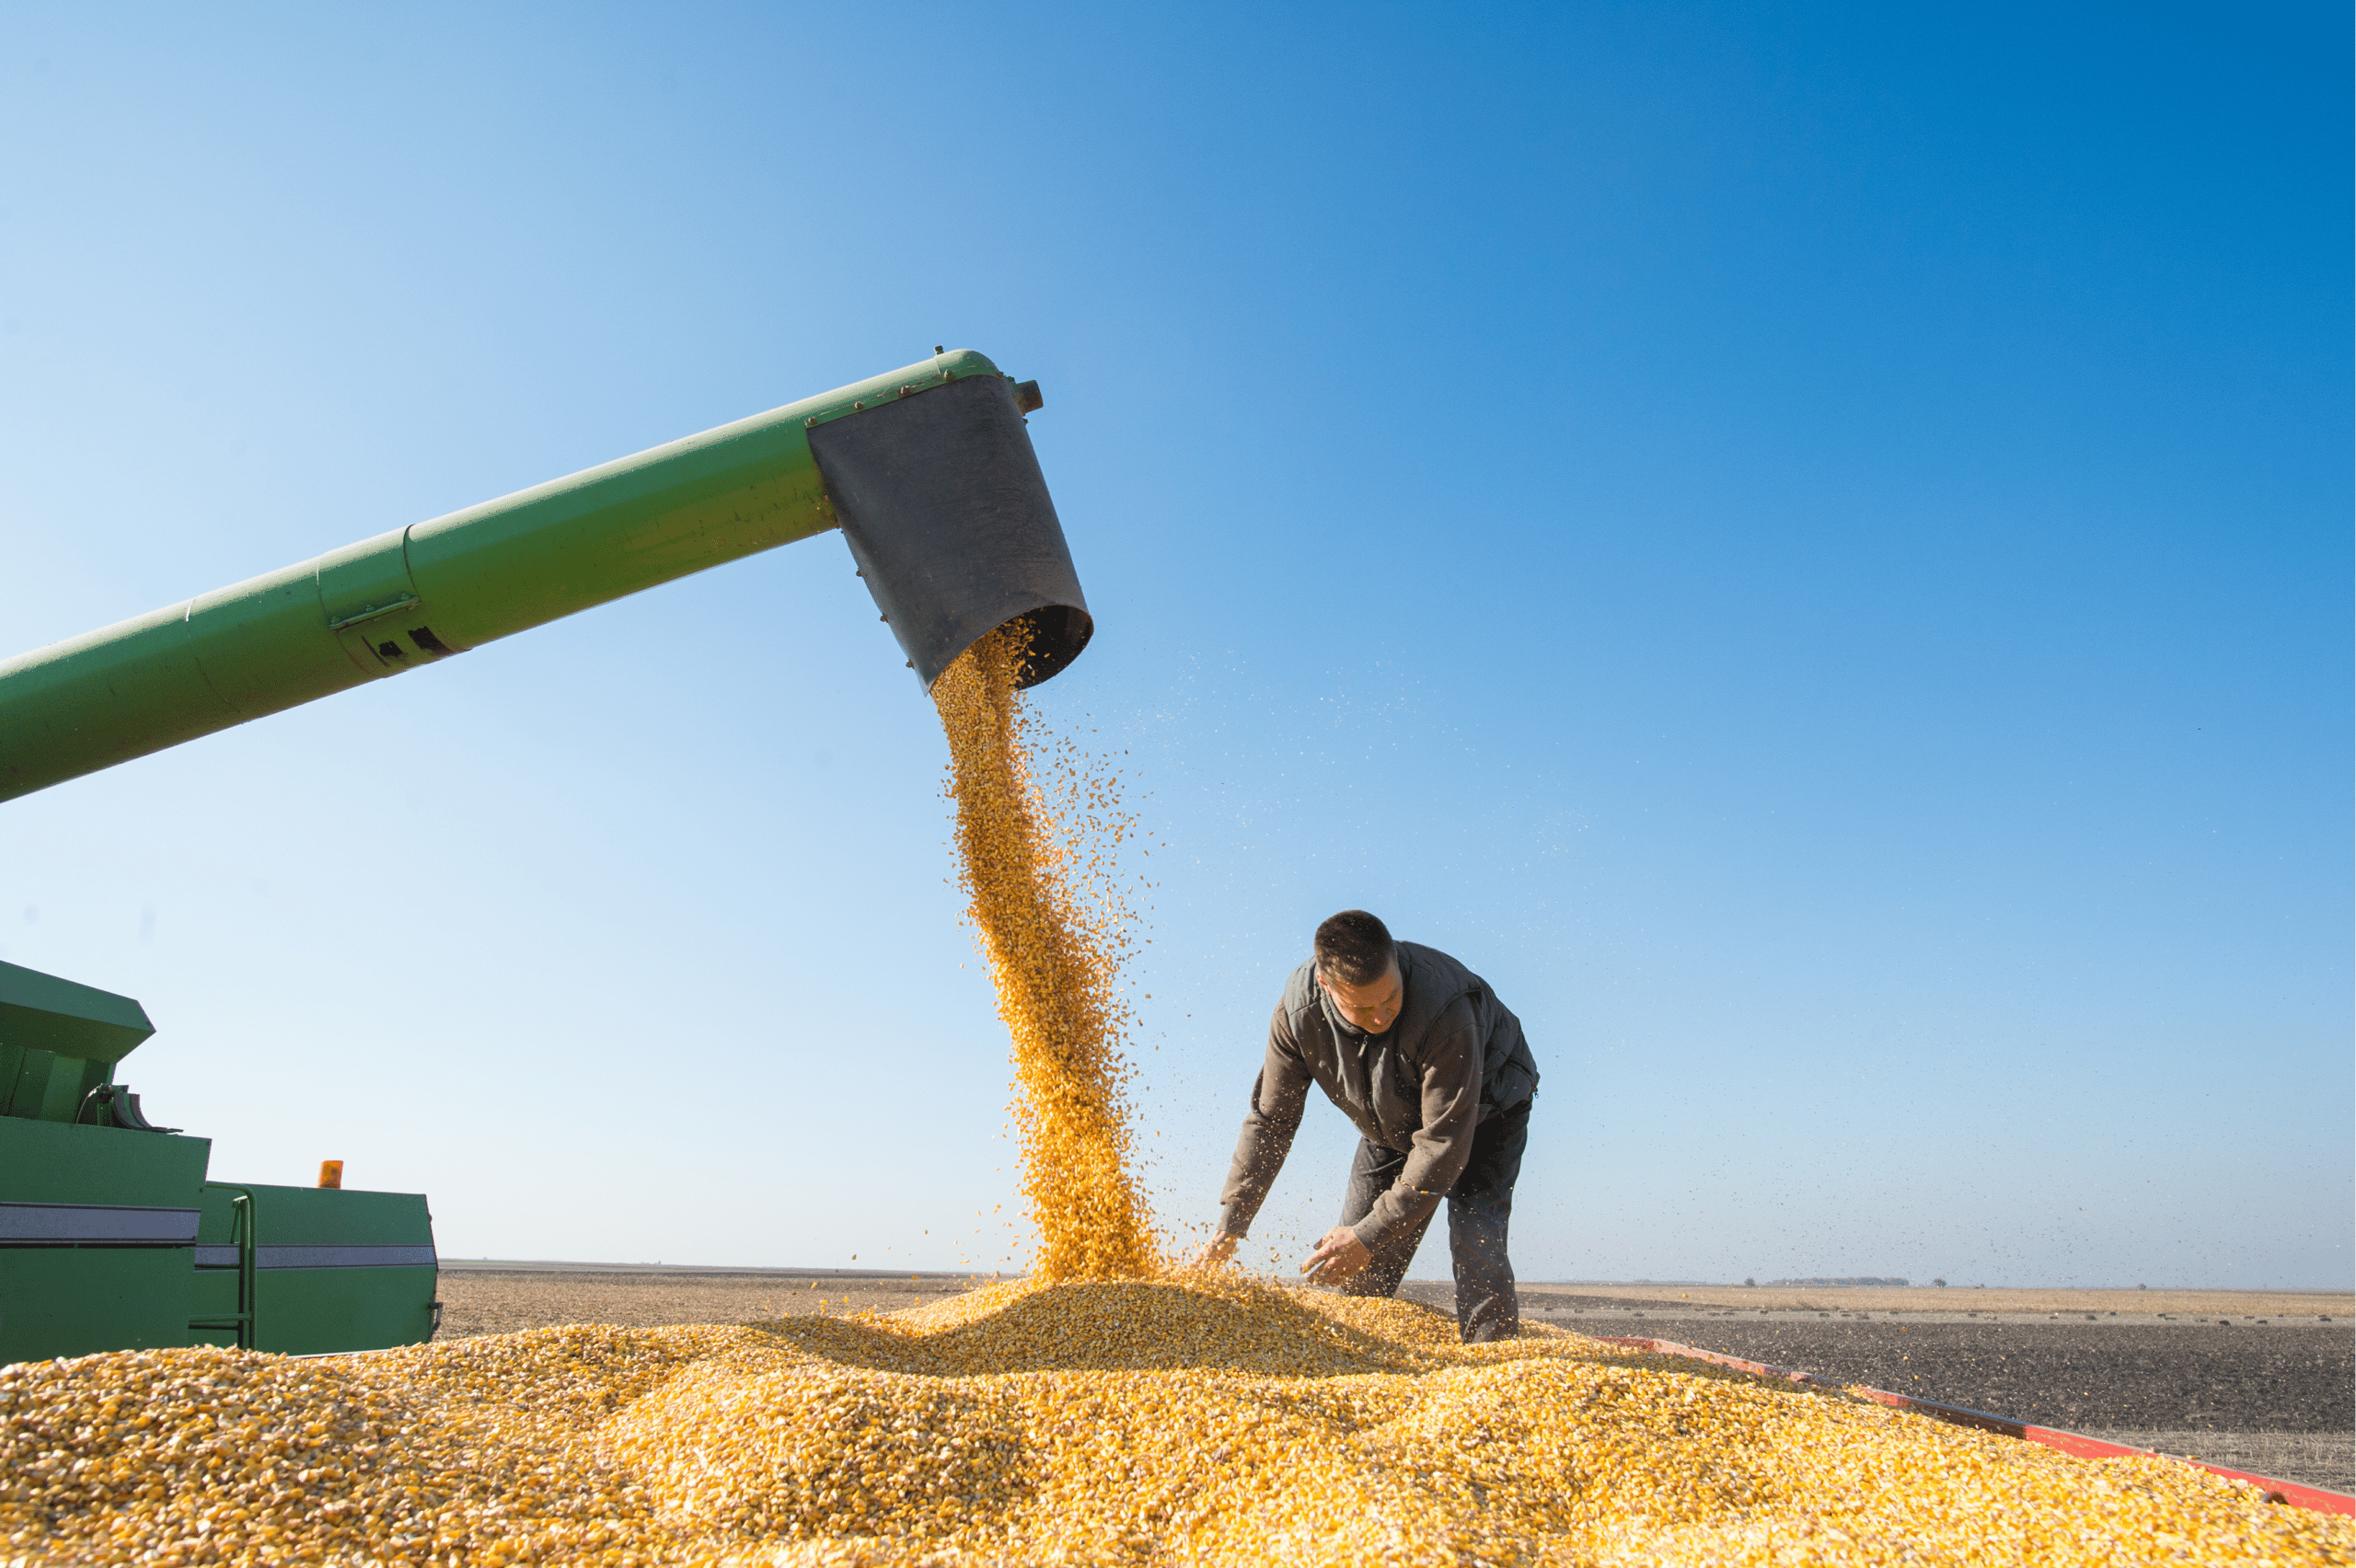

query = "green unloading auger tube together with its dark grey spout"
0;349;1093;801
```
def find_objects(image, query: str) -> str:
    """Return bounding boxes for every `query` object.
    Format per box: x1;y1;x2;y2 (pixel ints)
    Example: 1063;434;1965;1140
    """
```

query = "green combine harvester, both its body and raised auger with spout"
0;351;1093;1363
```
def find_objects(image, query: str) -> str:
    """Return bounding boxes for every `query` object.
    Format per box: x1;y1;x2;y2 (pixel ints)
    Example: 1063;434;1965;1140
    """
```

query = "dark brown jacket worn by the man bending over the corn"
1218;941;1539;1248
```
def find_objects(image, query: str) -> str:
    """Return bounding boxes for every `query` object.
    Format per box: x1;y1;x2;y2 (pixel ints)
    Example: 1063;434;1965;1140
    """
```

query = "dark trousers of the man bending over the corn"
1341;1100;1529;1344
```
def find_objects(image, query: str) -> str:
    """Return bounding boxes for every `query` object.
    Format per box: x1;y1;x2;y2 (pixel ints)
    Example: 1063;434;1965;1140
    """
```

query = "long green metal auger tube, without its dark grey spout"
0;351;1001;801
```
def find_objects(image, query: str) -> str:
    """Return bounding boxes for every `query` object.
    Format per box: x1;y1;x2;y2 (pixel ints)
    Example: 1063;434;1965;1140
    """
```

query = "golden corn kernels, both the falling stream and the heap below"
0;638;2356;1568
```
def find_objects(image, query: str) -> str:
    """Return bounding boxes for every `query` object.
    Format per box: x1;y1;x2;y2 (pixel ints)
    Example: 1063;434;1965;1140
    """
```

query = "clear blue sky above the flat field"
0;5;2356;1288
